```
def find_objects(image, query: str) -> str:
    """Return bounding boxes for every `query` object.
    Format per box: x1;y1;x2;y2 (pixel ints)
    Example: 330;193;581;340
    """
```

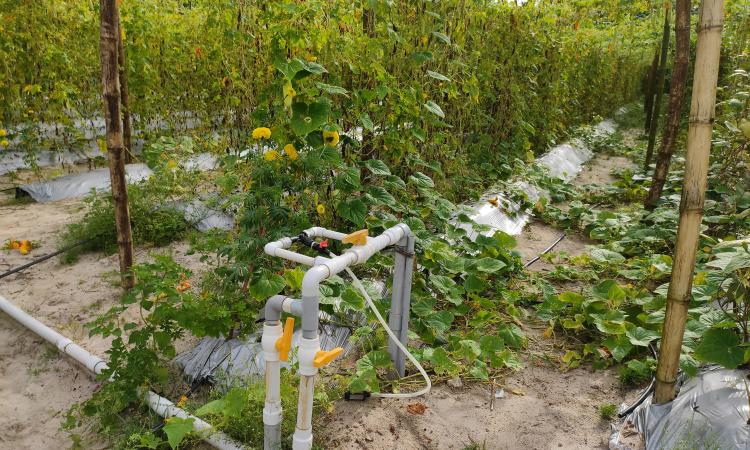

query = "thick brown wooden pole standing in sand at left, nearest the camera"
99;0;134;289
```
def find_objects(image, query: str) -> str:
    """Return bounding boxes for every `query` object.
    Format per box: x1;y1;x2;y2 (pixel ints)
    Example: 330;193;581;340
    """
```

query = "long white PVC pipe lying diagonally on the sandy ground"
0;295;244;450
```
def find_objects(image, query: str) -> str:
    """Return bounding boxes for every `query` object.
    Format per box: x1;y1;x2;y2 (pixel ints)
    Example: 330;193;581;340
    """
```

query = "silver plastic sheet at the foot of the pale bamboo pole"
609;367;750;450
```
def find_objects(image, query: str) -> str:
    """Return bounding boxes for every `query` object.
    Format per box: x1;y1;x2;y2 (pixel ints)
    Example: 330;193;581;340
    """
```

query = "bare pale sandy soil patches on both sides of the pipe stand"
0;146;640;450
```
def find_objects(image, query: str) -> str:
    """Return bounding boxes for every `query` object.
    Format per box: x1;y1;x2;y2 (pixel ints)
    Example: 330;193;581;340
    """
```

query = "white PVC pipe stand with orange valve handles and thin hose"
261;224;431;450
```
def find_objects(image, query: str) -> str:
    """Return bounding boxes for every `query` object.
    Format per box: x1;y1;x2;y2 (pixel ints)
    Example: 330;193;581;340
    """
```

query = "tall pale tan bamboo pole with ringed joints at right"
654;0;724;403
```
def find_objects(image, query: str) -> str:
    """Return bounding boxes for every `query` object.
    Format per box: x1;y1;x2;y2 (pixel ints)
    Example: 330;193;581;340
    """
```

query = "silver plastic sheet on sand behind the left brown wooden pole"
18;164;153;203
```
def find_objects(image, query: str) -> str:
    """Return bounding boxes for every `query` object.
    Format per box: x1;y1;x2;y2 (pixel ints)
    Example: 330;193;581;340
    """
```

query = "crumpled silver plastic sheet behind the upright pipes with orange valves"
174;313;353;388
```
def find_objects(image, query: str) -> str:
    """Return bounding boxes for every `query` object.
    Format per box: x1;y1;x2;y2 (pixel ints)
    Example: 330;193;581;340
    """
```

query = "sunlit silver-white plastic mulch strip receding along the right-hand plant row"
458;119;617;240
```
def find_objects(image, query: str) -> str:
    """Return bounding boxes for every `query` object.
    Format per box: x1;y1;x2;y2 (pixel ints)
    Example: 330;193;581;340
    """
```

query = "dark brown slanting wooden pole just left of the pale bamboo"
644;0;690;209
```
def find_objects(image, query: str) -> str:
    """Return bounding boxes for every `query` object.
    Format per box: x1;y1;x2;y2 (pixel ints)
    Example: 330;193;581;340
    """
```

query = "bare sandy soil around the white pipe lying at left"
0;191;206;450
